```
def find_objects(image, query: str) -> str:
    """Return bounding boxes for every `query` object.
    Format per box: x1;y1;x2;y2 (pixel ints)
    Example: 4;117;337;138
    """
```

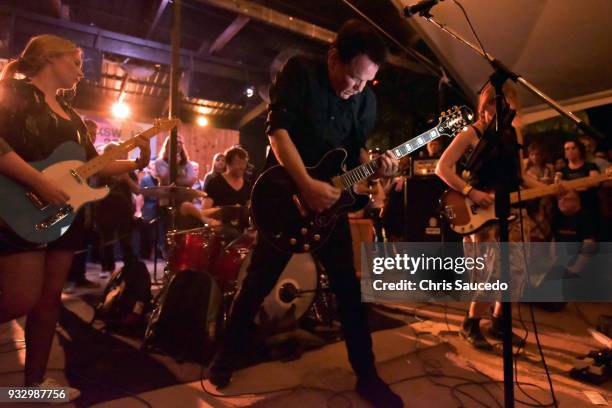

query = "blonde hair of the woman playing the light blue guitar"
0;34;82;80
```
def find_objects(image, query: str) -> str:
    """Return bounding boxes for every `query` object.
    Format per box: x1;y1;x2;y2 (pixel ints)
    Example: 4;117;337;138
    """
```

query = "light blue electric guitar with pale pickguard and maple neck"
0;119;179;244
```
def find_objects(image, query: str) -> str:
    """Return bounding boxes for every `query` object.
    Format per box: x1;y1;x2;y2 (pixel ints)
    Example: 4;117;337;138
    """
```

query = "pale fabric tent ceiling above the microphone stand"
396;0;612;119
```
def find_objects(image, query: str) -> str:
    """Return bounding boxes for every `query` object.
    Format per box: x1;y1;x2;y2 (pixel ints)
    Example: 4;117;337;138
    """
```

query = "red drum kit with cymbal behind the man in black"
143;186;335;356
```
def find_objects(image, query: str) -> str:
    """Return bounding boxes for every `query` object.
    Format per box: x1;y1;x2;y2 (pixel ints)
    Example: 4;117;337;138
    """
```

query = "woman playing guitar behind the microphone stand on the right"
436;82;544;350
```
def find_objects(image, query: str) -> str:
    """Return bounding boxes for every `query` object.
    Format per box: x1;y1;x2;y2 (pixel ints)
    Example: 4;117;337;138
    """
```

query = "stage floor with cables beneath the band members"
0;263;612;408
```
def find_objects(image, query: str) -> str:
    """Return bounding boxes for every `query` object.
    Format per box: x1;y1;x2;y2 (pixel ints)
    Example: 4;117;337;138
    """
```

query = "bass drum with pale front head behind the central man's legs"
230;244;318;323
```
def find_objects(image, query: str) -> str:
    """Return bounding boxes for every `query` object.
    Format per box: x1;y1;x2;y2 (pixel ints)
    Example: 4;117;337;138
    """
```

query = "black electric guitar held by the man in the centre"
251;106;474;253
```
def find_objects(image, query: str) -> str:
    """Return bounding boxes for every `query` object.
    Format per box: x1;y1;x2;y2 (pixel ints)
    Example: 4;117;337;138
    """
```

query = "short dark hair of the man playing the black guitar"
332;20;388;65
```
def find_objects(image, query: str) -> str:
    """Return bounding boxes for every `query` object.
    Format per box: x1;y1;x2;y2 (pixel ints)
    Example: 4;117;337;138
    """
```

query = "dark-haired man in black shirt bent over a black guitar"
210;21;402;407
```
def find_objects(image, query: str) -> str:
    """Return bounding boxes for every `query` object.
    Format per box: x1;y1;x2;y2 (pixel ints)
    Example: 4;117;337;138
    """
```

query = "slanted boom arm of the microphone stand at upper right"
423;14;605;139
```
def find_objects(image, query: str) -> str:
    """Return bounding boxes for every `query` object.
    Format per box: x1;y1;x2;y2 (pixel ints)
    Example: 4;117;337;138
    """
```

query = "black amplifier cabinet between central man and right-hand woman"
403;176;462;242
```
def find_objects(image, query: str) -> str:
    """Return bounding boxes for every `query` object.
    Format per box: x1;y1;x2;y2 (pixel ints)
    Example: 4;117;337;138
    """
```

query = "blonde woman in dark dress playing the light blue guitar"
0;34;150;400
